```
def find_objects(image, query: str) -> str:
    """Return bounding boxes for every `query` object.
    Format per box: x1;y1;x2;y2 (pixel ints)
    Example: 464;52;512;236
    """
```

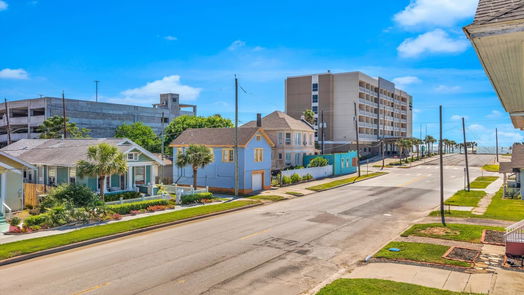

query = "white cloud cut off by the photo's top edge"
393;0;478;29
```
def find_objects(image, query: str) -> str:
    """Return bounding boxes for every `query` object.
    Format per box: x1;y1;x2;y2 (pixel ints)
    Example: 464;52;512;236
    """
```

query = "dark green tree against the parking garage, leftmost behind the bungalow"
38;116;91;139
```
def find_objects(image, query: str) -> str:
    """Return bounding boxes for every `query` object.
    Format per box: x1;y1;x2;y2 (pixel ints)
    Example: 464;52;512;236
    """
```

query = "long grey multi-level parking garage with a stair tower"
0;93;197;146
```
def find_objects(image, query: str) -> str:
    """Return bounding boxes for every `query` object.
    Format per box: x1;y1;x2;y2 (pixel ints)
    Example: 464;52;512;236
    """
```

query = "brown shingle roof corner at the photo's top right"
474;0;524;25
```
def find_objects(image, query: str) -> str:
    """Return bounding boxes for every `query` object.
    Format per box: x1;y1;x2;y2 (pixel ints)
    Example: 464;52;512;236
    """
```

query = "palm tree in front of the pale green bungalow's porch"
76;143;127;200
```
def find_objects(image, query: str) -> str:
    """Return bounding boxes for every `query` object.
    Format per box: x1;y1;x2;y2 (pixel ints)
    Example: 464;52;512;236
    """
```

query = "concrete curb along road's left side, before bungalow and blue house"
0;203;264;266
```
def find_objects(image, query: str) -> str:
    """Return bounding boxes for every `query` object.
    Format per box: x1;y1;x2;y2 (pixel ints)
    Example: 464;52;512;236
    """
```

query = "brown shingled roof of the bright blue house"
170;127;274;147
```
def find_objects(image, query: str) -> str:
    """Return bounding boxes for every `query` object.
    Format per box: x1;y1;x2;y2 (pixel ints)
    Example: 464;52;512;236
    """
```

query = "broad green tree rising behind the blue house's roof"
164;115;234;153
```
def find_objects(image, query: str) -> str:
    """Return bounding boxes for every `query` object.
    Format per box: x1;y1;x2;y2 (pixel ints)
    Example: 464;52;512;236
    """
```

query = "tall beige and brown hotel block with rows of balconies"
285;72;413;154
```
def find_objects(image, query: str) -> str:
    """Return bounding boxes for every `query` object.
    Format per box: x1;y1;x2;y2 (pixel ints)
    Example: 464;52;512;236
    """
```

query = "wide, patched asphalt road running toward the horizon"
0;156;494;295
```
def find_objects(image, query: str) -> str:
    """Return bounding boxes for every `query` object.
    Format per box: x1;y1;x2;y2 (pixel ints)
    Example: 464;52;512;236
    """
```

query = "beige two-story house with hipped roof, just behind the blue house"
242;111;316;170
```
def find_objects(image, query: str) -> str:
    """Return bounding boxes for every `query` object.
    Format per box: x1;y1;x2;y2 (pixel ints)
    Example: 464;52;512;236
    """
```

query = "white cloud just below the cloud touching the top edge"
397;29;469;58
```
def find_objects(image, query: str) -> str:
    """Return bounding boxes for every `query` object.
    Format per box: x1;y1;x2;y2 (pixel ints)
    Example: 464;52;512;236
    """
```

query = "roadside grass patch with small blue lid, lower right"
375;242;471;267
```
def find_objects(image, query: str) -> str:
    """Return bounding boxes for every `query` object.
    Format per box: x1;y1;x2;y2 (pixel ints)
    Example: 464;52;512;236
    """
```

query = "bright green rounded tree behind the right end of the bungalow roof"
115;122;161;153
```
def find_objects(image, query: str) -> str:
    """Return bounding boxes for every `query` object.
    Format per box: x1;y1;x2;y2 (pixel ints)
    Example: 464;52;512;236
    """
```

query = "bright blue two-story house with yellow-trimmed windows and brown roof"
170;127;274;194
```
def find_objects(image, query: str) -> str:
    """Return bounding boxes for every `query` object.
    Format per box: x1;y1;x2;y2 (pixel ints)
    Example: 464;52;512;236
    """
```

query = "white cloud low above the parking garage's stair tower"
119;75;202;105
